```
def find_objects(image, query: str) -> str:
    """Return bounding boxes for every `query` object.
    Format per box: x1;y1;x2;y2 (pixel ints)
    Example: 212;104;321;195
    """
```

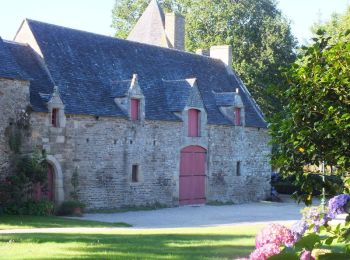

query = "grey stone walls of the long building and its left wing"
0;80;271;208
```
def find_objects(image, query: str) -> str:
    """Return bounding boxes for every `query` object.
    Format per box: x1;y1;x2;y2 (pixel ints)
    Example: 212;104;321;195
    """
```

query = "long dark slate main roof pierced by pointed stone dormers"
7;20;266;127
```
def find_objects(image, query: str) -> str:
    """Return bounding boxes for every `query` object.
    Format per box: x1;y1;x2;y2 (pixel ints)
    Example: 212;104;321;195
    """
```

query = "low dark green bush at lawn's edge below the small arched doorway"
4;200;54;216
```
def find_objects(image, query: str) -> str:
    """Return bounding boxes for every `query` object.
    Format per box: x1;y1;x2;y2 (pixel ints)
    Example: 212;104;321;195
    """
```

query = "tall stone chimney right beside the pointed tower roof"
165;13;185;51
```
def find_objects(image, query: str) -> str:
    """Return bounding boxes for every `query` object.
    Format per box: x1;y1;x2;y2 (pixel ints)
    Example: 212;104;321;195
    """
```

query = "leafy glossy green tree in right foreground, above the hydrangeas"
270;31;350;203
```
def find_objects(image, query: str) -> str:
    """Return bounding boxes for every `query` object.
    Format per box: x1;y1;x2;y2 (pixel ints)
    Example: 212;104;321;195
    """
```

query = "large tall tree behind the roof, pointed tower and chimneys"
112;0;296;116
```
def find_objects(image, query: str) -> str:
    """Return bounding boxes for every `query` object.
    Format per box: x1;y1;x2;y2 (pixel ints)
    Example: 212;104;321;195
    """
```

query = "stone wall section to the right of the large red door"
207;126;271;203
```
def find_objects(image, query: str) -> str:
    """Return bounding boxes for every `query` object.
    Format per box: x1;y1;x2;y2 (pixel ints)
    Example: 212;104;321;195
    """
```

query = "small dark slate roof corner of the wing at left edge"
0;38;30;80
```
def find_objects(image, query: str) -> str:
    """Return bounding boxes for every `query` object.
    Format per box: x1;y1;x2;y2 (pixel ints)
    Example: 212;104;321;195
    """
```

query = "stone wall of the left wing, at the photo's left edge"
0;79;29;179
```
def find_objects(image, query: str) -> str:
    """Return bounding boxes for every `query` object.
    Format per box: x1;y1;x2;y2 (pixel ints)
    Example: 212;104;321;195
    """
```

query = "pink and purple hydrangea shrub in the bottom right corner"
237;194;350;260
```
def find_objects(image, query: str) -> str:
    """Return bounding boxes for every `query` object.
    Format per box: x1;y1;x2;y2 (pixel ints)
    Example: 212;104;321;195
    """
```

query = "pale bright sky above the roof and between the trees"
0;0;350;43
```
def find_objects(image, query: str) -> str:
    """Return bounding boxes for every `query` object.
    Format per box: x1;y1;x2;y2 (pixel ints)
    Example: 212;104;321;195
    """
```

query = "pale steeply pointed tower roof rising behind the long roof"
127;0;171;47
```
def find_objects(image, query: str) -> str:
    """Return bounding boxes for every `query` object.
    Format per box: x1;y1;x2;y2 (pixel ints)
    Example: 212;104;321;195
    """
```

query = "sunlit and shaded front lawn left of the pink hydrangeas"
0;225;262;259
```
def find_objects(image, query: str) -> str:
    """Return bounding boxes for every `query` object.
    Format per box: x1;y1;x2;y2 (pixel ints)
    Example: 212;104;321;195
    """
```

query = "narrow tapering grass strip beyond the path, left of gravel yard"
0;215;130;230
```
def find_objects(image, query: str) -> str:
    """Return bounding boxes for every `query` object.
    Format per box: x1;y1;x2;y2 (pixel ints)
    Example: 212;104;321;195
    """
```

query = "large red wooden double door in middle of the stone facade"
179;146;206;205
